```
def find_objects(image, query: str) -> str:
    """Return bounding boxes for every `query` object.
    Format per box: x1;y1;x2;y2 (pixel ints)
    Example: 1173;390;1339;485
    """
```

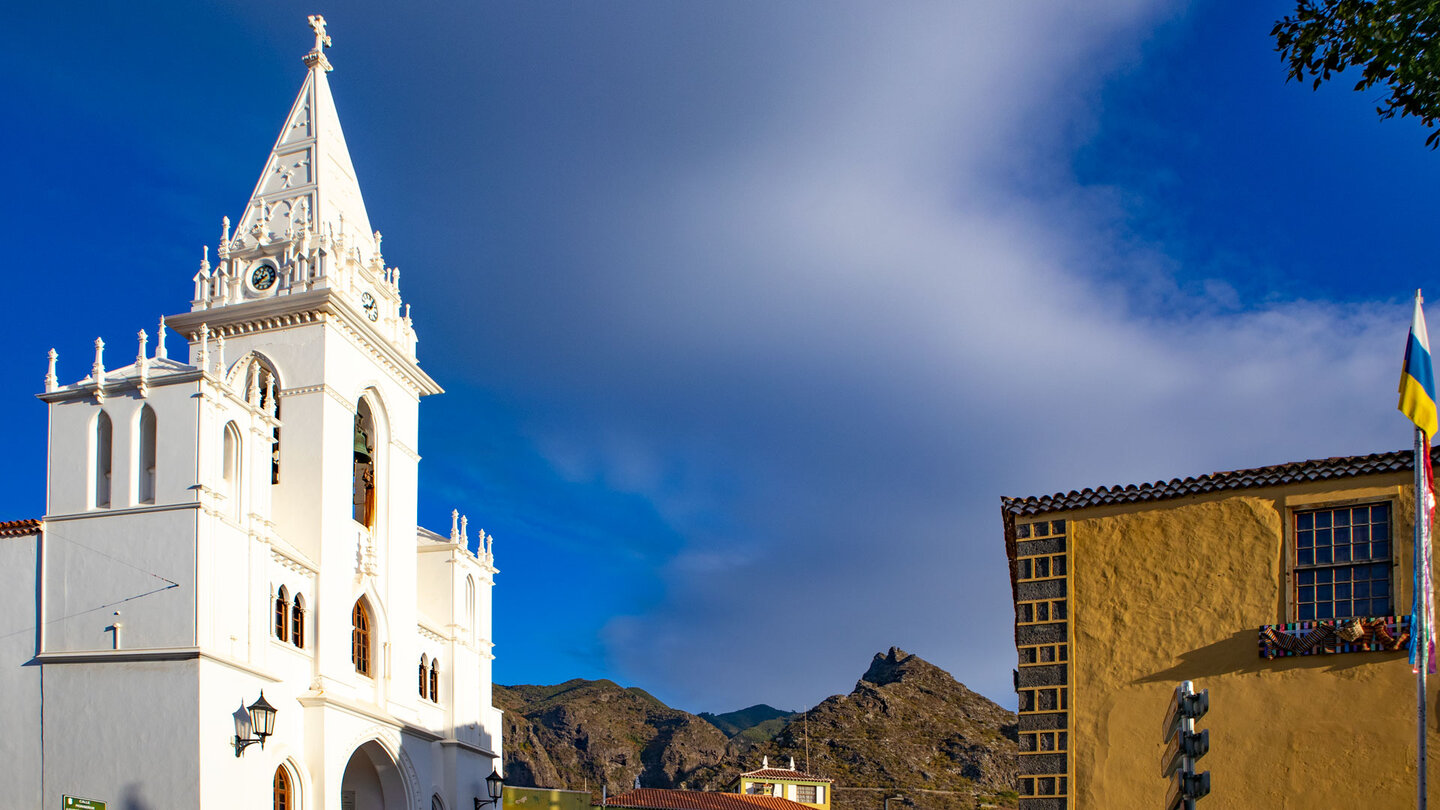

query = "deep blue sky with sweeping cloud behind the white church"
8;0;1440;711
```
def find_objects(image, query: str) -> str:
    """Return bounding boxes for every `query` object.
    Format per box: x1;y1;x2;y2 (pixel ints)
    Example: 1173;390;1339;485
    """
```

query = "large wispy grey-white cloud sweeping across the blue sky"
408;3;1404;711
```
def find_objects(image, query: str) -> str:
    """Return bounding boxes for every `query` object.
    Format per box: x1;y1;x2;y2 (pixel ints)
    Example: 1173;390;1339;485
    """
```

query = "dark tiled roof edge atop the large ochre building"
999;448;1440;515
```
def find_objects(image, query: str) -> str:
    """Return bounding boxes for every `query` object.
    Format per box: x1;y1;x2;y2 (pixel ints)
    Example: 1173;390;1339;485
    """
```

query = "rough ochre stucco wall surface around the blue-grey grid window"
1065;473;1440;810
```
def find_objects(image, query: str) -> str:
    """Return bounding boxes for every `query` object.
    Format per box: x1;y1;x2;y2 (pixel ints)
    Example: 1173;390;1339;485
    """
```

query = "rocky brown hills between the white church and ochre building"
495;647;1018;810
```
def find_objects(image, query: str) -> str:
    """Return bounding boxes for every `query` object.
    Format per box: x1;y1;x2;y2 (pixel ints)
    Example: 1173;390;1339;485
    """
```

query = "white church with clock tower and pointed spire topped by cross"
0;17;501;810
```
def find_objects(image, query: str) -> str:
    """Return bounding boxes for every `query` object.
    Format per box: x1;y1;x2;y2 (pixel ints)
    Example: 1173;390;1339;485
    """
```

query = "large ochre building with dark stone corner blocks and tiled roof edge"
1002;451;1440;810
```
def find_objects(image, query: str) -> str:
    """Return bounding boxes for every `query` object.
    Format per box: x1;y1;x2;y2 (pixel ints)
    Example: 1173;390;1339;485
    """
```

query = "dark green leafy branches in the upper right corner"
1270;0;1440;148
